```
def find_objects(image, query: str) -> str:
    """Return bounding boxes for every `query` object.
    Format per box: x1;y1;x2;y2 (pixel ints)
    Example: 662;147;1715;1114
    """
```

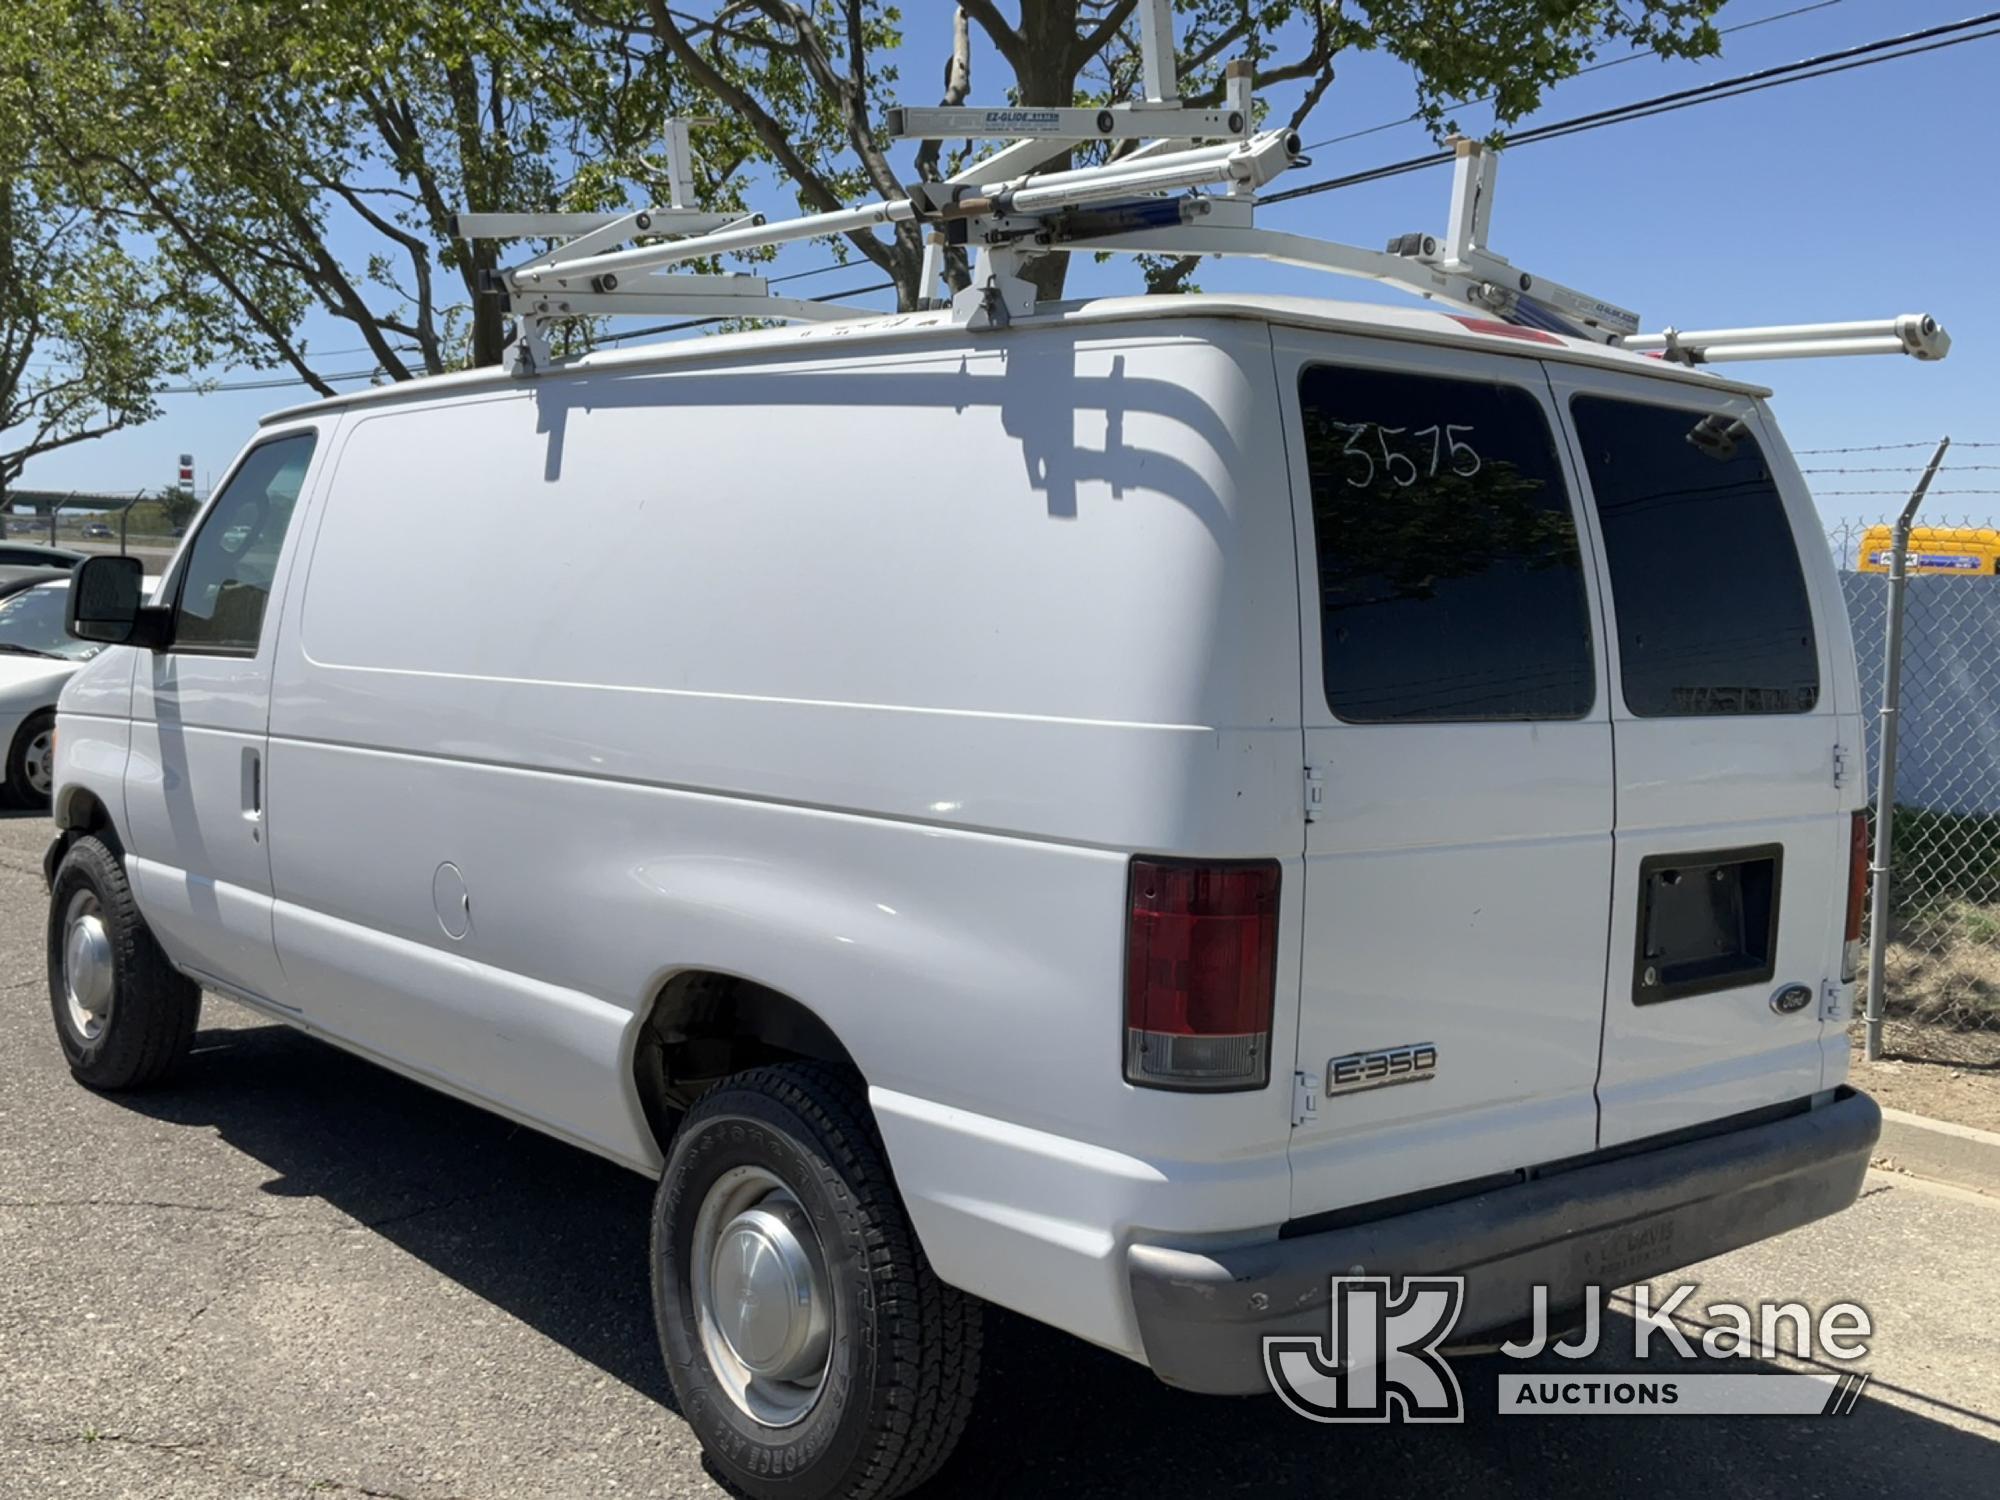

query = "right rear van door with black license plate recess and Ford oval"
1548;364;1860;1146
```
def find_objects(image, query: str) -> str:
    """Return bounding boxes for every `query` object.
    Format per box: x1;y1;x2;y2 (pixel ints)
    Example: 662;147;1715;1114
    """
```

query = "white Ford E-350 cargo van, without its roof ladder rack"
48;296;1878;1494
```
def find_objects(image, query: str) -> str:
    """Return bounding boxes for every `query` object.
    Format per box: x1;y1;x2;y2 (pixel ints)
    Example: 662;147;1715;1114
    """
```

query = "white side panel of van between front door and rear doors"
270;322;1302;1352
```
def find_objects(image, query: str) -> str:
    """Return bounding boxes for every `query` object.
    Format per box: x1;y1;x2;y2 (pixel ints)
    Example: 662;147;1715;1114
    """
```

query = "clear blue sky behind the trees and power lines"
20;0;2000;520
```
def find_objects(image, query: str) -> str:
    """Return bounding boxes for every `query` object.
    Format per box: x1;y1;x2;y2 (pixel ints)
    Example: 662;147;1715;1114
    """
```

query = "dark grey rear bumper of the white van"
1128;1090;1882;1394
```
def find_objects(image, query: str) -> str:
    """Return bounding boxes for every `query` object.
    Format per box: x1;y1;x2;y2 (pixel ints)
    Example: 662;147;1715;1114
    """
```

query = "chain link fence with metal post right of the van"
1826;512;2000;1032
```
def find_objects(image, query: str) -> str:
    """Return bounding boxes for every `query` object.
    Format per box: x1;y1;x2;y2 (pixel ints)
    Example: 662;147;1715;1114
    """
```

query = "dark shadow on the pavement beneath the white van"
120;1026;2000;1500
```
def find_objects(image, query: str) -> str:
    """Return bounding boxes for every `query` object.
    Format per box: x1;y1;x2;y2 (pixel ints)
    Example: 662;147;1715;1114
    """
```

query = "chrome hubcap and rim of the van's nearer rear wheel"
688;1166;832;1428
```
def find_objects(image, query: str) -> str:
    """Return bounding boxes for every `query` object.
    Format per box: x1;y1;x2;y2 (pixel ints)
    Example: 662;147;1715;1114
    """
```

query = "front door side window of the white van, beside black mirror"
174;432;316;656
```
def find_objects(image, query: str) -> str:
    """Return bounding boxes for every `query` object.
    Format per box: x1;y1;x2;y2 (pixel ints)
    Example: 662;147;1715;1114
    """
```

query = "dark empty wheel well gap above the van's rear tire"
632;970;860;1152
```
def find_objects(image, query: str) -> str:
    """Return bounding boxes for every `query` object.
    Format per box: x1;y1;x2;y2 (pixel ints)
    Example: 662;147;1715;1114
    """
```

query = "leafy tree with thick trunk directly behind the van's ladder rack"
572;0;1720;306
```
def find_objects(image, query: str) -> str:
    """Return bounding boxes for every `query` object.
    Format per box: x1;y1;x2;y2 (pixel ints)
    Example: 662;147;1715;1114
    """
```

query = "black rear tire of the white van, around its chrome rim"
652;1062;980;1500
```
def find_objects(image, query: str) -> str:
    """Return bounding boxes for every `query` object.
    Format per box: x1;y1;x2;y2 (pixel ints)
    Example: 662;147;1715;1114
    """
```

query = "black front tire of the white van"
48;836;202;1090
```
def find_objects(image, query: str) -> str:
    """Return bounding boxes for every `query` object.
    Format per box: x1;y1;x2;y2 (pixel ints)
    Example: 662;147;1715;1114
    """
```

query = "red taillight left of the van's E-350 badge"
1124;860;1278;1088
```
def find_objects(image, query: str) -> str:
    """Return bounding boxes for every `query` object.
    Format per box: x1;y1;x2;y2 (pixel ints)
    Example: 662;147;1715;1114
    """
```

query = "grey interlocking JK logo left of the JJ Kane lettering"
1264;1276;1466;1422
